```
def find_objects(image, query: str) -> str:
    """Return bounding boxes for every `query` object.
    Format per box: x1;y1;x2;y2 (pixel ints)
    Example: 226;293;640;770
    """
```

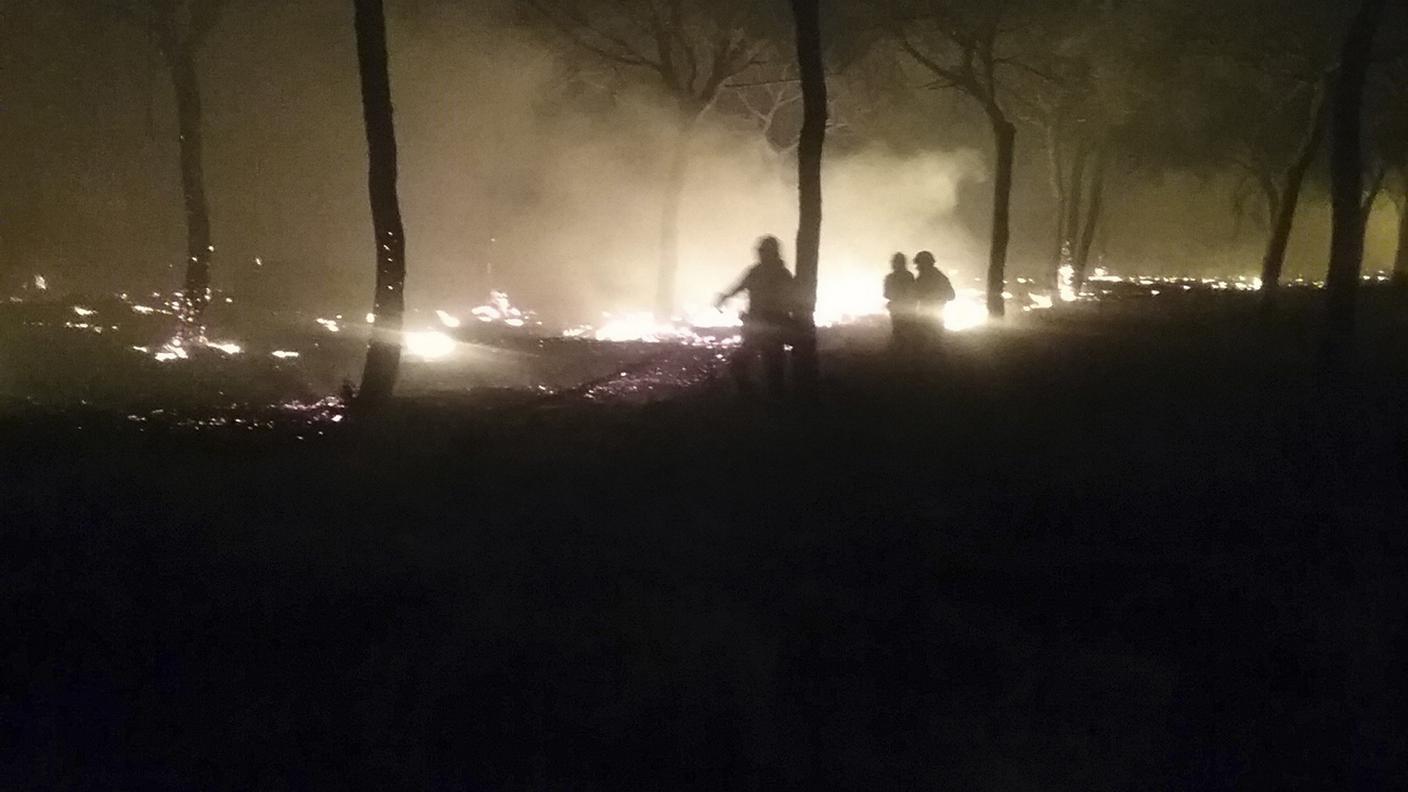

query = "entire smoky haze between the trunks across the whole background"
19;0;1395;314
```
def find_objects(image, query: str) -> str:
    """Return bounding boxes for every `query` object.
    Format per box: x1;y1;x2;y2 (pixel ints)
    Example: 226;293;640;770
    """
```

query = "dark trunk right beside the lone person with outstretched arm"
791;0;828;395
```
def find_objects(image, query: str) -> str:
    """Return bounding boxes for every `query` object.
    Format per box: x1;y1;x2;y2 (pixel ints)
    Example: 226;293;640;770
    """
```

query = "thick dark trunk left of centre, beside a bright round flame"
353;0;406;406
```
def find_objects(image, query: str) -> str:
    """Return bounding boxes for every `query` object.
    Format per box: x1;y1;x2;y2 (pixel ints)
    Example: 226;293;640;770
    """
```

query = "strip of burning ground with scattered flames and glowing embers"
0;271;1340;426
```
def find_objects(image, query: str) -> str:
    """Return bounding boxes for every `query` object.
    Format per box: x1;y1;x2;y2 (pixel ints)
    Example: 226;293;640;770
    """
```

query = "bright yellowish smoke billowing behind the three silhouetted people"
380;2;984;318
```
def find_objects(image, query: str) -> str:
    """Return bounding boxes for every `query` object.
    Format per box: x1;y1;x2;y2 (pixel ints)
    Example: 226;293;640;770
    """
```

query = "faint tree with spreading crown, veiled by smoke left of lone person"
524;0;774;320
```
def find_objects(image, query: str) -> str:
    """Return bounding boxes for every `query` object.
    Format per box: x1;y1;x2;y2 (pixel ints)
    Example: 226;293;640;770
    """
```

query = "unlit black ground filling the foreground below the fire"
0;297;1408;791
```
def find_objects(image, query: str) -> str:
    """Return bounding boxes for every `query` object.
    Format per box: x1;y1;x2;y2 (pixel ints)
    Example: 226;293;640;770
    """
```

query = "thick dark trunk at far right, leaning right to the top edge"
1325;0;1385;339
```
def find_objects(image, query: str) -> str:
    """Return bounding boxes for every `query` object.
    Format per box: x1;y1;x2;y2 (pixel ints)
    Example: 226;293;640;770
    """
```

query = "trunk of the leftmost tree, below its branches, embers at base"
166;41;215;333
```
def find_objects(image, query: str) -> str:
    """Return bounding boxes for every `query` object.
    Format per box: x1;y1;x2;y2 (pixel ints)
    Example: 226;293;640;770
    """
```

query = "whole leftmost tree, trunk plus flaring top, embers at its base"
103;0;228;337
